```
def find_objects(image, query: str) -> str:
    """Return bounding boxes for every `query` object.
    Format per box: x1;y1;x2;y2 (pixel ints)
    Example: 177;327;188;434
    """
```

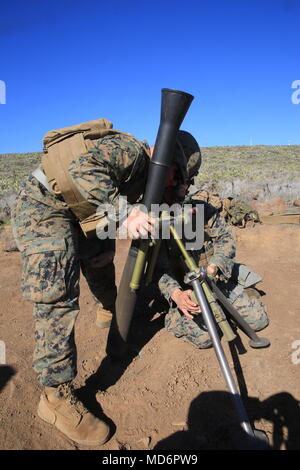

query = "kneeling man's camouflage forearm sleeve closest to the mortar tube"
153;242;180;304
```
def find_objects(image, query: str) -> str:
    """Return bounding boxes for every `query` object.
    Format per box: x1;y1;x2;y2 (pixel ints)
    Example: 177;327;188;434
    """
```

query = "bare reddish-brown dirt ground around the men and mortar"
0;225;300;450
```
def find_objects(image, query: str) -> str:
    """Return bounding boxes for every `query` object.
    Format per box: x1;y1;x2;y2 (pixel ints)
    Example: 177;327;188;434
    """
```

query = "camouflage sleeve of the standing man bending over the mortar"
68;135;146;218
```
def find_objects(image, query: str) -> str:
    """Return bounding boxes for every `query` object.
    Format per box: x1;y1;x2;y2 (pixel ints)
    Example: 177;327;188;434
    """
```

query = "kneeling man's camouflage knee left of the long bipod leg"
165;308;212;349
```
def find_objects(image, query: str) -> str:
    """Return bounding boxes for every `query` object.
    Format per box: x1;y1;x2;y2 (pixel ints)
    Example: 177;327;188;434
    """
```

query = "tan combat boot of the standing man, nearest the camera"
38;383;109;446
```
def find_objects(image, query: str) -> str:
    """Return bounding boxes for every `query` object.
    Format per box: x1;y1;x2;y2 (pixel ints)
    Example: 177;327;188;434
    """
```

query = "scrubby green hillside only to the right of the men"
196;145;300;200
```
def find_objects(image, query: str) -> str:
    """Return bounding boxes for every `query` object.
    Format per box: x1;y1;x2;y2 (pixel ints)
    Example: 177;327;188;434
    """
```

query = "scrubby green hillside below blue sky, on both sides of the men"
0;145;300;198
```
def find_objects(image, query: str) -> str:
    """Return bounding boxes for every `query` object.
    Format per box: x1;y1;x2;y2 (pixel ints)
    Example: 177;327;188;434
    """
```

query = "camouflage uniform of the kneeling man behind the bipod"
157;201;268;348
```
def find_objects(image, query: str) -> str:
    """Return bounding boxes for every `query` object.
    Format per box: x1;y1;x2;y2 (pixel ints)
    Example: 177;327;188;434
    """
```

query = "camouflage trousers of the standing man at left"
12;177;116;386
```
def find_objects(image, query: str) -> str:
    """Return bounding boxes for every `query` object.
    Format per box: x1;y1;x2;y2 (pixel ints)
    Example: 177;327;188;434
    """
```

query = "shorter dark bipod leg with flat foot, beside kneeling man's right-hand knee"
205;276;270;348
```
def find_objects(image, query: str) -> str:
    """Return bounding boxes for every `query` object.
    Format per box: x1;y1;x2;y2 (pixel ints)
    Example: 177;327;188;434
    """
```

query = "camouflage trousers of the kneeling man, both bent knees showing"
165;282;269;349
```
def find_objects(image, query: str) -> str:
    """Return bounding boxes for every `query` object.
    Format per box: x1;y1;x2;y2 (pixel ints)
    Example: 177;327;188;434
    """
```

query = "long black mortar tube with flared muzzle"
106;88;194;358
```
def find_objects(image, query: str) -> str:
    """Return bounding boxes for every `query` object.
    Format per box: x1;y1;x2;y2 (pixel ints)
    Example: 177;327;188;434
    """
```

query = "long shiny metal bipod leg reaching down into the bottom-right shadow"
186;272;255;438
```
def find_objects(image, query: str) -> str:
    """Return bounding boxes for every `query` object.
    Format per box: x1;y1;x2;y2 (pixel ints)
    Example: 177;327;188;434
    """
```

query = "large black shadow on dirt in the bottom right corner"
154;391;300;450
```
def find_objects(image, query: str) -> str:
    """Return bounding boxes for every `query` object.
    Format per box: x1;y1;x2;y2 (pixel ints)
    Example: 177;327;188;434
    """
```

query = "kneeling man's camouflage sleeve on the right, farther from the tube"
204;203;236;279
